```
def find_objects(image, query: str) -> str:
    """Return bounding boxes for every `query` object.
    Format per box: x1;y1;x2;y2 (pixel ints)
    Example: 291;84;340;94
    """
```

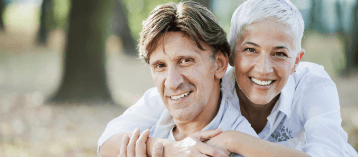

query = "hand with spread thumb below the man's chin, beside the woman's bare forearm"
164;129;230;157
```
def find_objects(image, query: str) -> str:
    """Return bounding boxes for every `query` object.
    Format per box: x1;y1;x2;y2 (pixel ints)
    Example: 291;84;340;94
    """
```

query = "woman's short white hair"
229;0;304;56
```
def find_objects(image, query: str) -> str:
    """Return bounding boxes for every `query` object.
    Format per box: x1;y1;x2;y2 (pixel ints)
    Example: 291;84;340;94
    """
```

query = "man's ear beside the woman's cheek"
214;51;229;79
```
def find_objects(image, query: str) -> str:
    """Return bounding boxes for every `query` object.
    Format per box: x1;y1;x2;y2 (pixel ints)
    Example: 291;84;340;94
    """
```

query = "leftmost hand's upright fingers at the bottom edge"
118;129;163;157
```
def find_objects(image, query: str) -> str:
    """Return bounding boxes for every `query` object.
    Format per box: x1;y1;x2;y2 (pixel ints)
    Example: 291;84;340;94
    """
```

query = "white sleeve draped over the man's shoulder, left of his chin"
97;87;165;151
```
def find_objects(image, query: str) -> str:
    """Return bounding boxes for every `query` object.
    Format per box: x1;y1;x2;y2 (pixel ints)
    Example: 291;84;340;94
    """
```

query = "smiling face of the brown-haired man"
149;32;222;123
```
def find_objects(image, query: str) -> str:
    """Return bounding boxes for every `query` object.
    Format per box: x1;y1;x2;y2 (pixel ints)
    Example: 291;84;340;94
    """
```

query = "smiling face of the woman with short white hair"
234;21;304;105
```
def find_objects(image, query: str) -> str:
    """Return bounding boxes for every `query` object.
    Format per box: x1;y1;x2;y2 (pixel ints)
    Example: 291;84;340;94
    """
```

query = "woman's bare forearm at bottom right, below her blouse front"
206;130;309;157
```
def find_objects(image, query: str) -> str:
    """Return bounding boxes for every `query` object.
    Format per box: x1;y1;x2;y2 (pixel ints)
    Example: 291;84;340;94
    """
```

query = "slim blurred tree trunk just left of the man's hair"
113;0;137;56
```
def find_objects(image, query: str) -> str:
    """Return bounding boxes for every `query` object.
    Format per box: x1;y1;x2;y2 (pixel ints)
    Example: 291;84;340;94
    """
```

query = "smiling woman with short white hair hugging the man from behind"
98;0;356;156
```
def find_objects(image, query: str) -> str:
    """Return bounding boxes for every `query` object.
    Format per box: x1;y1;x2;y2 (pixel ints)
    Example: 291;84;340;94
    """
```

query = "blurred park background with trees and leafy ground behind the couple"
0;0;358;157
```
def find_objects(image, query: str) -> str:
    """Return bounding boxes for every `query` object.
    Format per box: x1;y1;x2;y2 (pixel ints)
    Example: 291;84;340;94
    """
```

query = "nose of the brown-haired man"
165;67;184;90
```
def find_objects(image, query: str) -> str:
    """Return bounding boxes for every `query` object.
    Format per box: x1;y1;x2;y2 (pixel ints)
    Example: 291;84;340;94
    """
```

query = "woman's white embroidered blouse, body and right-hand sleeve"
222;62;358;157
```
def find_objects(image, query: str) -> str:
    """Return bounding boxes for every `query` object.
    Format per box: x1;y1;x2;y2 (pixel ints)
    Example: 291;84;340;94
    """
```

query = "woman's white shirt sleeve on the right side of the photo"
295;69;350;157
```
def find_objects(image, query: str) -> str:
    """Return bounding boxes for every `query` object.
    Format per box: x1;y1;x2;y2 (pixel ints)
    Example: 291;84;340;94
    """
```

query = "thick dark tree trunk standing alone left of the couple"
51;0;114;103
